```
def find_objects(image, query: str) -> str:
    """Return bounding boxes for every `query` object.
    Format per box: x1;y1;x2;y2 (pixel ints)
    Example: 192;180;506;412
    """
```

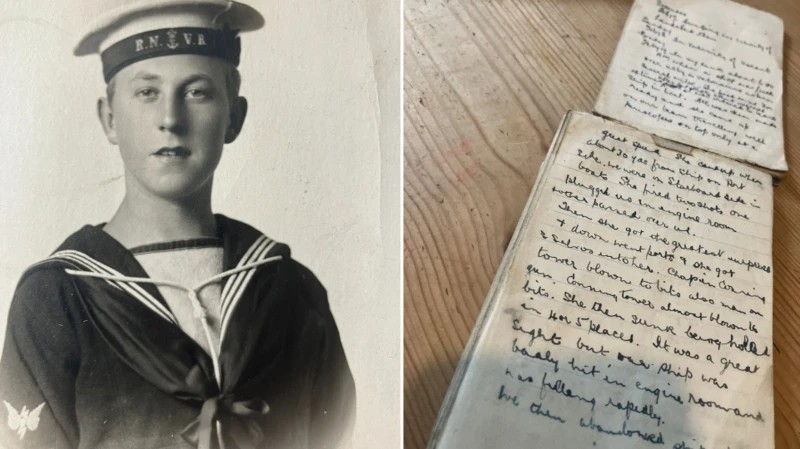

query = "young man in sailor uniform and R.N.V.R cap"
0;0;355;449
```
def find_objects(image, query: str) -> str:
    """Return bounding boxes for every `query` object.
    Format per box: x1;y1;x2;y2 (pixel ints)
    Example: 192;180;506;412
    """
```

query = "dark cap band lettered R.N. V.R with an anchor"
100;28;241;82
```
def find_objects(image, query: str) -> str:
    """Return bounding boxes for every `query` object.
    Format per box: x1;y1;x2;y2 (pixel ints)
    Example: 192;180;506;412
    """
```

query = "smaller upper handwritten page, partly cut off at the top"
595;0;787;171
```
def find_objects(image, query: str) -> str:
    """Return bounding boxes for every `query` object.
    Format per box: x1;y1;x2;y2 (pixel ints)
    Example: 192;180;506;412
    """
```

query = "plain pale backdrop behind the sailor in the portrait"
0;0;402;448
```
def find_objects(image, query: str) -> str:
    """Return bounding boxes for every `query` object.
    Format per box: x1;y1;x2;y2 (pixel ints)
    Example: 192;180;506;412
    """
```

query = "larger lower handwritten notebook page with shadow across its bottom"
430;113;774;449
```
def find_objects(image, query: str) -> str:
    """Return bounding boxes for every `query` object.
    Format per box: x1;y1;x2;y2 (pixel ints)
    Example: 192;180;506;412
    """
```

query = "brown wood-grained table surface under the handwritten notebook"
404;0;800;449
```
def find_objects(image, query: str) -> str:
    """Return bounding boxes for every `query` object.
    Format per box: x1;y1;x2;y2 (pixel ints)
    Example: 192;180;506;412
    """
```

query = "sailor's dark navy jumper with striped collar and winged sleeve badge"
0;215;355;449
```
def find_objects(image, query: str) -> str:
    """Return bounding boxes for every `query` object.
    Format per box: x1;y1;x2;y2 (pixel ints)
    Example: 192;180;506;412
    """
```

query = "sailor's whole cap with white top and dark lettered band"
74;0;264;82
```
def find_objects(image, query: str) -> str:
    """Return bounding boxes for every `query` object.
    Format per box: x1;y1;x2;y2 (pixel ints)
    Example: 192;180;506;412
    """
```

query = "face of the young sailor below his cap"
106;55;232;200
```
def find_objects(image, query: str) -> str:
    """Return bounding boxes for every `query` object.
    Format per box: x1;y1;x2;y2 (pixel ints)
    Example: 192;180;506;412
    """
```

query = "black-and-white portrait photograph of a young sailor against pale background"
0;0;402;449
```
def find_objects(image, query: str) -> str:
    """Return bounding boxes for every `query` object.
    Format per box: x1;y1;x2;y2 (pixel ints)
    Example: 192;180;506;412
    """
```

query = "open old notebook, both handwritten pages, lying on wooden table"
429;0;787;449
